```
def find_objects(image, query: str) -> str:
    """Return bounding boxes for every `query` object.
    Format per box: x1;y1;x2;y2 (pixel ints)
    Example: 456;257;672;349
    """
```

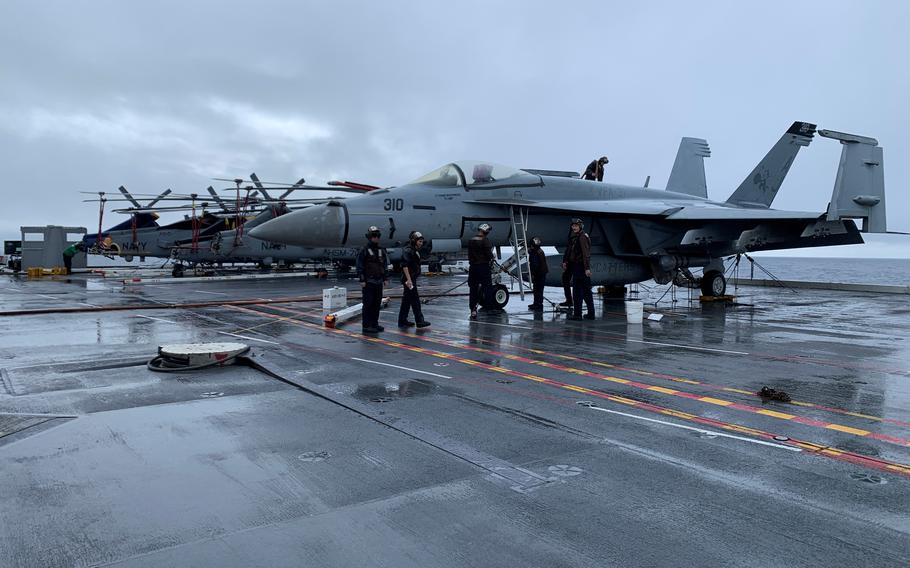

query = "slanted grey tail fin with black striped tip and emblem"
727;122;815;207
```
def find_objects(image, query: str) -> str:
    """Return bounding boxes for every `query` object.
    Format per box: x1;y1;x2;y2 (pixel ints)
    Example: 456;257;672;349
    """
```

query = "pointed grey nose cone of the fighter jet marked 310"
250;203;347;247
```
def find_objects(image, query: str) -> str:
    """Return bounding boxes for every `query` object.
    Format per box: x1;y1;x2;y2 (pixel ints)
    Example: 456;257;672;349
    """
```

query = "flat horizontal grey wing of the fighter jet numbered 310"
466;199;821;221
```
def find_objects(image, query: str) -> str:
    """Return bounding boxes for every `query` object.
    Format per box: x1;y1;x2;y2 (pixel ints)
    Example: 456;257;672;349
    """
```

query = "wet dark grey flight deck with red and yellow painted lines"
0;276;910;567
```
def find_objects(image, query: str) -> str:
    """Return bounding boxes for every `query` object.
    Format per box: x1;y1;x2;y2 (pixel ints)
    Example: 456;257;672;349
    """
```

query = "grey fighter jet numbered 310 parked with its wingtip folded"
250;122;886;305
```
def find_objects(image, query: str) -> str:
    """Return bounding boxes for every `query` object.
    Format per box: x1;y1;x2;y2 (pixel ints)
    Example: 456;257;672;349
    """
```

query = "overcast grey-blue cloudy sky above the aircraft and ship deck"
0;0;910;257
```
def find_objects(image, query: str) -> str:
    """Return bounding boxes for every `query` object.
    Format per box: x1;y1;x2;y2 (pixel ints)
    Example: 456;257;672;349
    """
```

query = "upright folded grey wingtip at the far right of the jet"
818;130;888;233
